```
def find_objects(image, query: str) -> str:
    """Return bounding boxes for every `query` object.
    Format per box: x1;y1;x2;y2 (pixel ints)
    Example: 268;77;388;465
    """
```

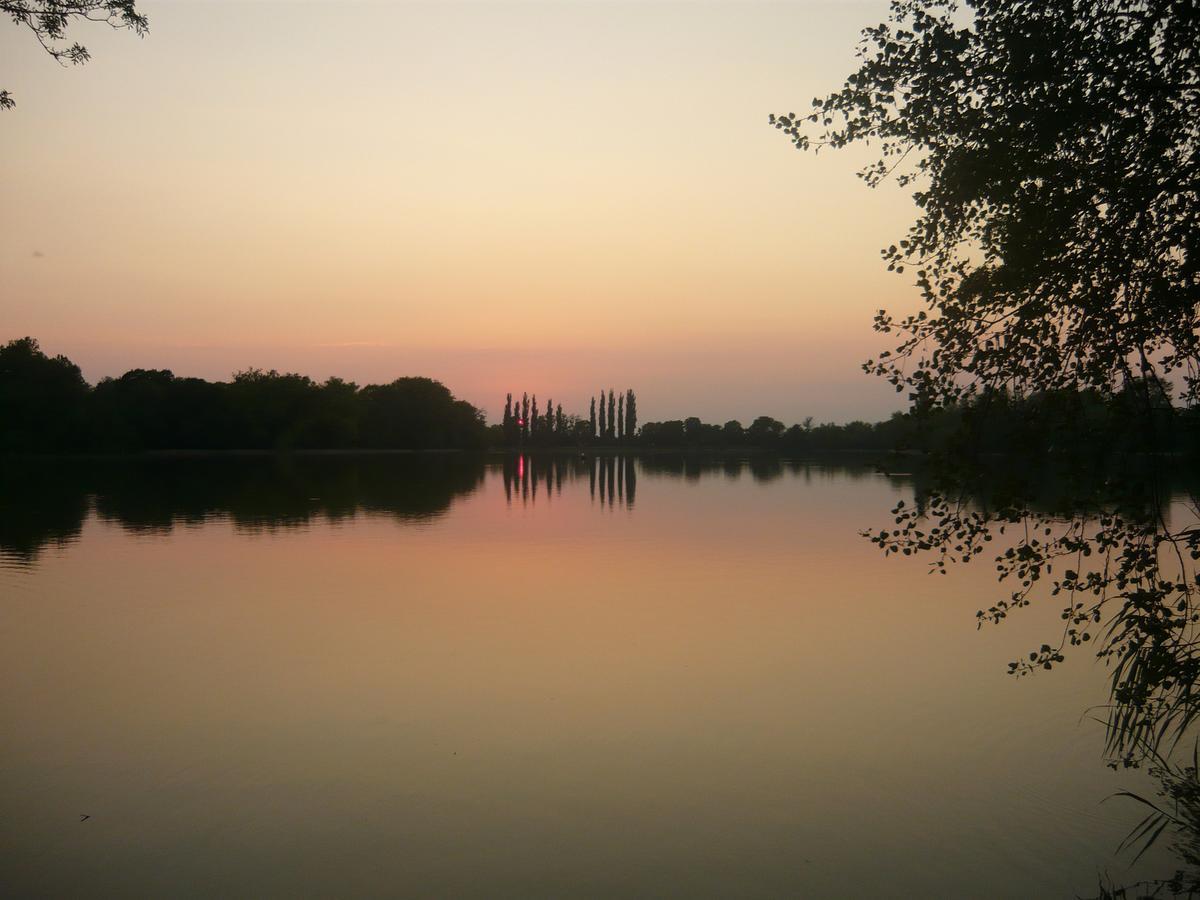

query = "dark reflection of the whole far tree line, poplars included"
0;454;888;565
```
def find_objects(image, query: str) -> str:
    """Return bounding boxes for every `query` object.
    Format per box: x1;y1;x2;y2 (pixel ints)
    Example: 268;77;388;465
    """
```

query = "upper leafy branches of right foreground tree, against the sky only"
772;0;1200;415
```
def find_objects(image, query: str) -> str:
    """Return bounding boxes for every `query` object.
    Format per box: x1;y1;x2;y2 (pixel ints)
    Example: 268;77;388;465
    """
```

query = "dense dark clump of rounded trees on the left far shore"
0;337;487;452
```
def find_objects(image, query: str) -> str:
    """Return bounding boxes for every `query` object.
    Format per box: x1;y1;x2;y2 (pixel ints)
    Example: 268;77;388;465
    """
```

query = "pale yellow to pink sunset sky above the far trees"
0;0;917;422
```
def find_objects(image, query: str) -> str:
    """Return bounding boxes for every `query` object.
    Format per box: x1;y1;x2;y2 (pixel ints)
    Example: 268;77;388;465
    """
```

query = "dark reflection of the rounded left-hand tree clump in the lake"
0;454;485;565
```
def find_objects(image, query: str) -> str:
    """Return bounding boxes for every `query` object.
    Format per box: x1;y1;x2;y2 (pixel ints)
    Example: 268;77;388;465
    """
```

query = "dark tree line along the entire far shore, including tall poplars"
7;337;1200;457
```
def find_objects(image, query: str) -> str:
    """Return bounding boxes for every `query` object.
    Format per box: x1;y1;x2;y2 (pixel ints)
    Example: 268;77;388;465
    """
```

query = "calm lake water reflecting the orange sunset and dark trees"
0;457;1172;898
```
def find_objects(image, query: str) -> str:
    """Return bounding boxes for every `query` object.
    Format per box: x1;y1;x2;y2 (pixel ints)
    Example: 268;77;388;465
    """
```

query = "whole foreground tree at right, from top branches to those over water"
772;0;1200;777
